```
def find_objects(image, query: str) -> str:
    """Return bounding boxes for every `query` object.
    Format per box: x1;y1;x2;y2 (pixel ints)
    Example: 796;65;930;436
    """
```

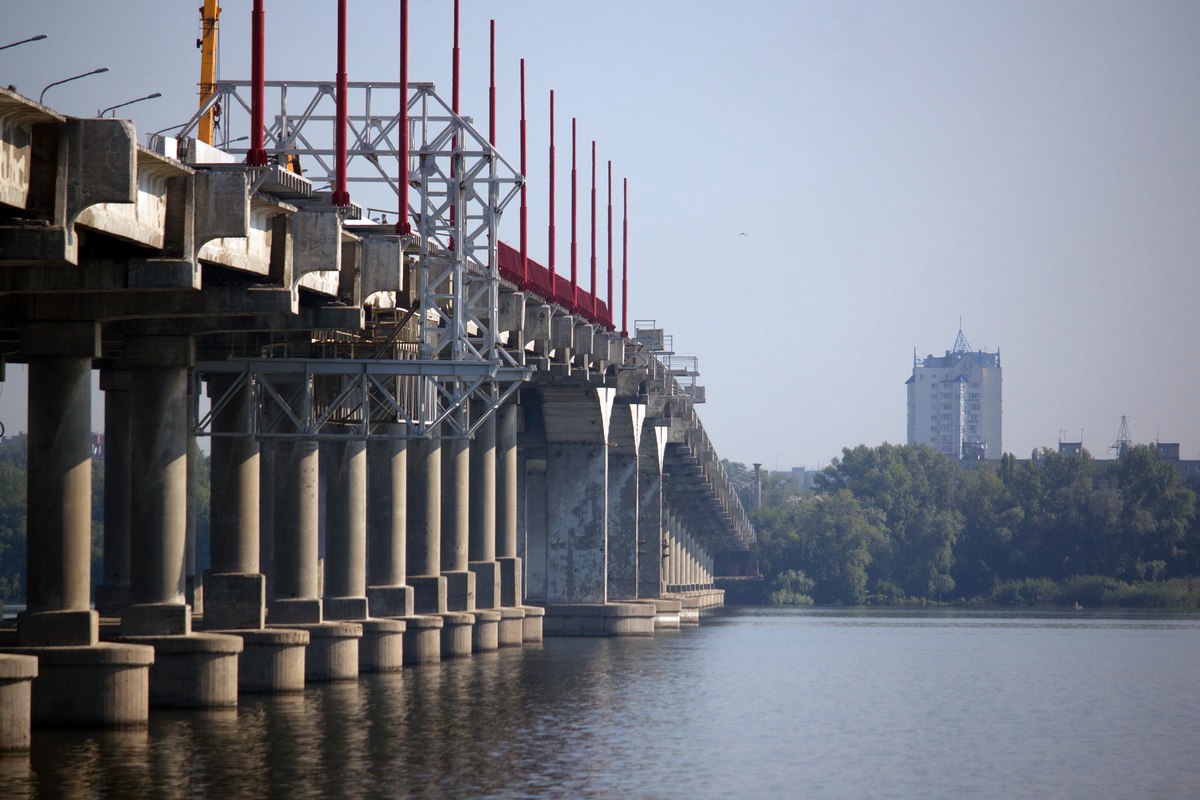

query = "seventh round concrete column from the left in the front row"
407;439;446;614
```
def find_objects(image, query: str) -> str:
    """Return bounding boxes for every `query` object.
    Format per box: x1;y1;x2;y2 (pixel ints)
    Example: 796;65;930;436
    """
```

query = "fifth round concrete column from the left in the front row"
320;439;368;620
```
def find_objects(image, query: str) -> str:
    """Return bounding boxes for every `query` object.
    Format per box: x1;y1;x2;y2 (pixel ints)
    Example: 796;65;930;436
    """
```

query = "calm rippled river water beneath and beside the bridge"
0;609;1200;800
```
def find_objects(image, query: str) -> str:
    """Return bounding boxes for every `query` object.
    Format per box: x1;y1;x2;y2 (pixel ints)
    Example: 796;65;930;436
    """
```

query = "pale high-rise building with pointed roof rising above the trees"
907;329;1001;459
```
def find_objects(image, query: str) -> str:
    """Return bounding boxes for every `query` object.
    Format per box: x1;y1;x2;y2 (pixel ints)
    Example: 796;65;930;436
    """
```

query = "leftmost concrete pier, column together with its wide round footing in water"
8;331;154;727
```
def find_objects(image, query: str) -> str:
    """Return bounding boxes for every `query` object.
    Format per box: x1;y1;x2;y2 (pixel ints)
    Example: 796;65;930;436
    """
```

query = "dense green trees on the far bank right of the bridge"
727;444;1200;607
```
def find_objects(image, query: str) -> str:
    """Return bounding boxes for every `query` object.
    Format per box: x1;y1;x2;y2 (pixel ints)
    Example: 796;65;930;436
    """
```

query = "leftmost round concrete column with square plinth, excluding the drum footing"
17;347;98;645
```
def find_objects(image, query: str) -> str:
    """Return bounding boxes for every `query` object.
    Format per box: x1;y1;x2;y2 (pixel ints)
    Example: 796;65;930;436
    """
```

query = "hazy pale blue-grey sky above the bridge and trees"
0;0;1200;468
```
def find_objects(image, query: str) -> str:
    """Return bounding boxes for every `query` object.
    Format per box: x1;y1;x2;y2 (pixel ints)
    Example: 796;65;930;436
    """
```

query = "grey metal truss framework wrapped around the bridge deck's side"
180;80;529;438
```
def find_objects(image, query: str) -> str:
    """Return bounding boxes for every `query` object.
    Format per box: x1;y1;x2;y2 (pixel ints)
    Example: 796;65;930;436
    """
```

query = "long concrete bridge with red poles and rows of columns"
0;2;756;748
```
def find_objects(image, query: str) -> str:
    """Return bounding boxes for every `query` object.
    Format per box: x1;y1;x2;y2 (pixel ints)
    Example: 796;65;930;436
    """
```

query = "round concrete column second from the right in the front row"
468;404;500;608
